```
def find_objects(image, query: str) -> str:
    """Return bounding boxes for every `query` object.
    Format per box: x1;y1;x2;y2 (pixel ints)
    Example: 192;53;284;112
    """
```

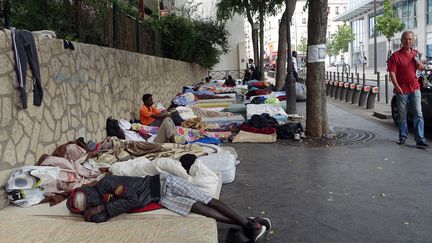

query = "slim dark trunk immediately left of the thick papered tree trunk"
284;0;297;114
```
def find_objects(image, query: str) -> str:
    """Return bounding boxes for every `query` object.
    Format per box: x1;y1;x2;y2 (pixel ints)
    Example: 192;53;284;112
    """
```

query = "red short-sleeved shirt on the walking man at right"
388;49;420;94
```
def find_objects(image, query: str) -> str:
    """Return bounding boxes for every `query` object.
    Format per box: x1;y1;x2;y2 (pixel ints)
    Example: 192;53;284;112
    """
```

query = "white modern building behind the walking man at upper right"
334;0;432;69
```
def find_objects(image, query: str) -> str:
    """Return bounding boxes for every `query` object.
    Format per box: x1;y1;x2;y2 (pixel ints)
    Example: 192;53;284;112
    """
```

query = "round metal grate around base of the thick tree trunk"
279;127;377;147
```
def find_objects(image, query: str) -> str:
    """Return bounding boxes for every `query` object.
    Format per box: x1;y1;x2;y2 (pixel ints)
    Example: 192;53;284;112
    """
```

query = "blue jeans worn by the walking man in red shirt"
396;89;425;142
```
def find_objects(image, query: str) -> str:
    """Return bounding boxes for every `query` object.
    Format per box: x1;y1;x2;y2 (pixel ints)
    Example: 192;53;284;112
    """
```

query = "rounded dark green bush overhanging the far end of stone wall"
146;15;229;68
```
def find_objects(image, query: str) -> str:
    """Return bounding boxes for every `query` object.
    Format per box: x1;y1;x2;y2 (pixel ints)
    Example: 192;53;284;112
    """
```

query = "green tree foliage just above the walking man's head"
376;0;405;41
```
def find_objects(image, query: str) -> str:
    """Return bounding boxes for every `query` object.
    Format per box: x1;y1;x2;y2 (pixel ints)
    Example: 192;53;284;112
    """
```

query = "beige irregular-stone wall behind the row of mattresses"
0;30;207;171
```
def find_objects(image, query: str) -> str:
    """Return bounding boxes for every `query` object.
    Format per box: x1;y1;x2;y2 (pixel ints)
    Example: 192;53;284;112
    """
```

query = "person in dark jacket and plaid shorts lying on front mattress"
66;155;271;241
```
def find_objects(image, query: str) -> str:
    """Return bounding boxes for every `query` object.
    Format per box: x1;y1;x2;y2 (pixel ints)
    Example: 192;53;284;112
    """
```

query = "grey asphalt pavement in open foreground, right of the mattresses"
218;101;432;243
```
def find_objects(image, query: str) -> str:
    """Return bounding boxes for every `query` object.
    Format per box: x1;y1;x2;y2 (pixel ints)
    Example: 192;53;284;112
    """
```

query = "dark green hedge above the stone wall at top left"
6;0;139;45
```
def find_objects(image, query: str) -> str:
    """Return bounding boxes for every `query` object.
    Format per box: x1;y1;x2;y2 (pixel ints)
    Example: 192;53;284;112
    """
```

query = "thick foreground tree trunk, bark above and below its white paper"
306;0;328;137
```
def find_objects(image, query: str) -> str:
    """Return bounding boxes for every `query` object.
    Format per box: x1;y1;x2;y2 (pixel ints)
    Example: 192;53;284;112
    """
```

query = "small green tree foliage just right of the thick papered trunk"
327;23;355;56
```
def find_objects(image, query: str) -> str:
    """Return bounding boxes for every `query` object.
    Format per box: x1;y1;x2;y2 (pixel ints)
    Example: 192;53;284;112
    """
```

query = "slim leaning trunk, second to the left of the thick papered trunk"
276;8;288;90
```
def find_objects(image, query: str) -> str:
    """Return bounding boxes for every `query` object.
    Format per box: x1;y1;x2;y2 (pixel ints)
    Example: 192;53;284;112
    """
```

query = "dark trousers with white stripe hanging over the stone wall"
11;28;43;109
